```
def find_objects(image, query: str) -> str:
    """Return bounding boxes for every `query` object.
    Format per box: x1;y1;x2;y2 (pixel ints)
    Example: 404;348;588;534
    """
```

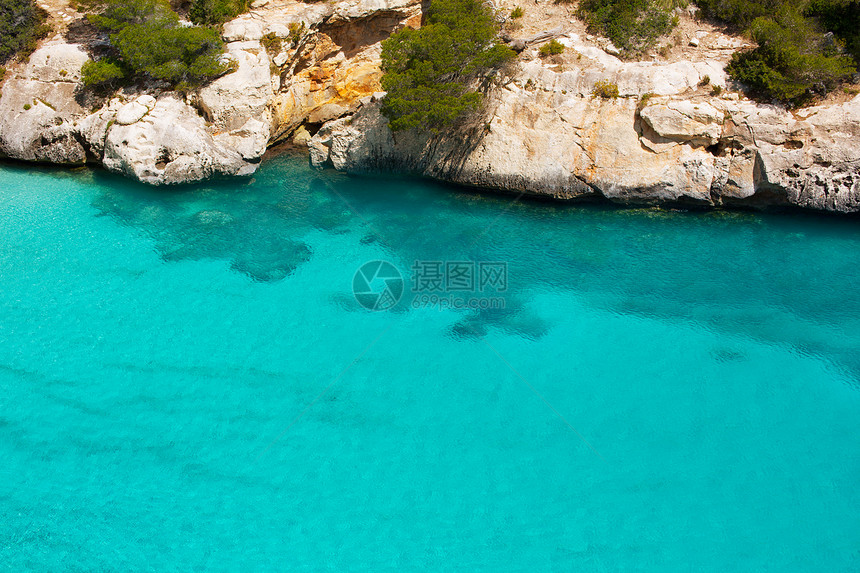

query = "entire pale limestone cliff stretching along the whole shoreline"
0;0;860;212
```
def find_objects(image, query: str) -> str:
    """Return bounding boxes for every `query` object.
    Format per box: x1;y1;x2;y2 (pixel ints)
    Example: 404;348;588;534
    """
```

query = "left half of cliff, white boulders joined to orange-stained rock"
0;0;421;185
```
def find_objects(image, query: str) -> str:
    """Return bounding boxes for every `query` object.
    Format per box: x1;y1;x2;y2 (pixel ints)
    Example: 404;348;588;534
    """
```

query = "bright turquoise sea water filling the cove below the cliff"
0;157;860;572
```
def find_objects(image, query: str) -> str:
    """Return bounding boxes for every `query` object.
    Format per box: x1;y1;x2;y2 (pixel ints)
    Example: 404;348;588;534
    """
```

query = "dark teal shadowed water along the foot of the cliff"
82;156;860;377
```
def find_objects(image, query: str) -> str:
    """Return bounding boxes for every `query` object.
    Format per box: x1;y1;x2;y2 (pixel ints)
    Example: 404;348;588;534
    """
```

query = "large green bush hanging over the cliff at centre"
382;0;516;133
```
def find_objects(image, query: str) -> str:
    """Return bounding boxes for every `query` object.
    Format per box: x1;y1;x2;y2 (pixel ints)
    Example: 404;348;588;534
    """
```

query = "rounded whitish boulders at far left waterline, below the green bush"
0;39;256;184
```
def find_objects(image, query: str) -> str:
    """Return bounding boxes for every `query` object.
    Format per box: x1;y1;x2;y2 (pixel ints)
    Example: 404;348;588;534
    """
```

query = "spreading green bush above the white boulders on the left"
83;0;247;90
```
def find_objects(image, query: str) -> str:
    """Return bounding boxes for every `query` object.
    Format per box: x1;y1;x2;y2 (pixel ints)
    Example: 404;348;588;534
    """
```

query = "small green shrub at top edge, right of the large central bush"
576;0;678;55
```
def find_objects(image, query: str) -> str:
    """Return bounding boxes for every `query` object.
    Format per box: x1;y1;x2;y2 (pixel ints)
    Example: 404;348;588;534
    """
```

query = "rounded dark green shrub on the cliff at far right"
726;8;855;106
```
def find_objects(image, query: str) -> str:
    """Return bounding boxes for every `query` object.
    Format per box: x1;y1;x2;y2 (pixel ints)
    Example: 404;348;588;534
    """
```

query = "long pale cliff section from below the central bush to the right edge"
309;30;860;212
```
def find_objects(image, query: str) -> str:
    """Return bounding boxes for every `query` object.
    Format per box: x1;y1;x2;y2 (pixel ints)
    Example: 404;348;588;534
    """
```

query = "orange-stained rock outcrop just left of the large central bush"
210;0;422;143
